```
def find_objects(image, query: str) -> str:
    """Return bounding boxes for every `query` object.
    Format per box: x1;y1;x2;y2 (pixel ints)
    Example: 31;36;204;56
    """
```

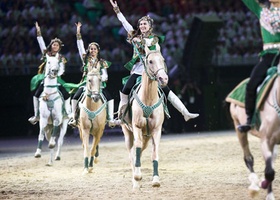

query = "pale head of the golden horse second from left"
87;67;101;102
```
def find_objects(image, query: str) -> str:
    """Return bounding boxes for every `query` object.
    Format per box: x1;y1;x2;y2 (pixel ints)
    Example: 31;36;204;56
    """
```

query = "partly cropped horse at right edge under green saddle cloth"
226;64;280;200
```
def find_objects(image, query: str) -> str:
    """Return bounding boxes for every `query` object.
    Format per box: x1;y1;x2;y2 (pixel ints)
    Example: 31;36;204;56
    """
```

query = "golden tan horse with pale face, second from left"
78;68;107;174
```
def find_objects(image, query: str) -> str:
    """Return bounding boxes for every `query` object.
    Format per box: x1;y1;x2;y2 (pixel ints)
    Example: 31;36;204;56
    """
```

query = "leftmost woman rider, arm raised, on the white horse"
28;22;71;125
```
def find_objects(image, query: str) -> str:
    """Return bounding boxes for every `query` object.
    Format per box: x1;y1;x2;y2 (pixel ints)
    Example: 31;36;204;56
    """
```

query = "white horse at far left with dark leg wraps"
35;55;69;166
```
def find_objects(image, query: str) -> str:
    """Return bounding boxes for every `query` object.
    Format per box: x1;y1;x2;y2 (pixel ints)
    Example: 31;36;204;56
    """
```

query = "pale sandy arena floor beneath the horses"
0;131;280;200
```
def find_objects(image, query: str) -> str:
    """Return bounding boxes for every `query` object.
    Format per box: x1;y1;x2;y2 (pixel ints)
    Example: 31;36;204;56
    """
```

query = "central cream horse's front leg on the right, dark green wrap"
152;131;161;187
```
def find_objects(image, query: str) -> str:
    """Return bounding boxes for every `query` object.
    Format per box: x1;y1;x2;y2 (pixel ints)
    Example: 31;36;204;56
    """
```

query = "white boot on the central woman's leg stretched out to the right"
167;90;199;121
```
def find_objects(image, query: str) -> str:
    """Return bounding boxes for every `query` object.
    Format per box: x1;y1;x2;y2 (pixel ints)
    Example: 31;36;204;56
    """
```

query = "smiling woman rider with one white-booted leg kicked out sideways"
110;0;199;123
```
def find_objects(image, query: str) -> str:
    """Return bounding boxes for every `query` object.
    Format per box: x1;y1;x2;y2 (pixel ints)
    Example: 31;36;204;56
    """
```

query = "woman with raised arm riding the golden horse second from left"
68;22;115;127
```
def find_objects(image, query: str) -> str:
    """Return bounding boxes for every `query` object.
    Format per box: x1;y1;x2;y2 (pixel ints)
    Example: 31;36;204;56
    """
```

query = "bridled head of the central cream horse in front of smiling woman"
145;44;168;87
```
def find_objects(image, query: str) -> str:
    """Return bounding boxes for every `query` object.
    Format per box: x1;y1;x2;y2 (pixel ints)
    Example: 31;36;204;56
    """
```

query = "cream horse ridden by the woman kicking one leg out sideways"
121;45;168;188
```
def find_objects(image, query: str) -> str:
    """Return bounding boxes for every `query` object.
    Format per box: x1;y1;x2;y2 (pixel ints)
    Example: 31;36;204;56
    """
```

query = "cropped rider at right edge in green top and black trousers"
237;0;280;132
